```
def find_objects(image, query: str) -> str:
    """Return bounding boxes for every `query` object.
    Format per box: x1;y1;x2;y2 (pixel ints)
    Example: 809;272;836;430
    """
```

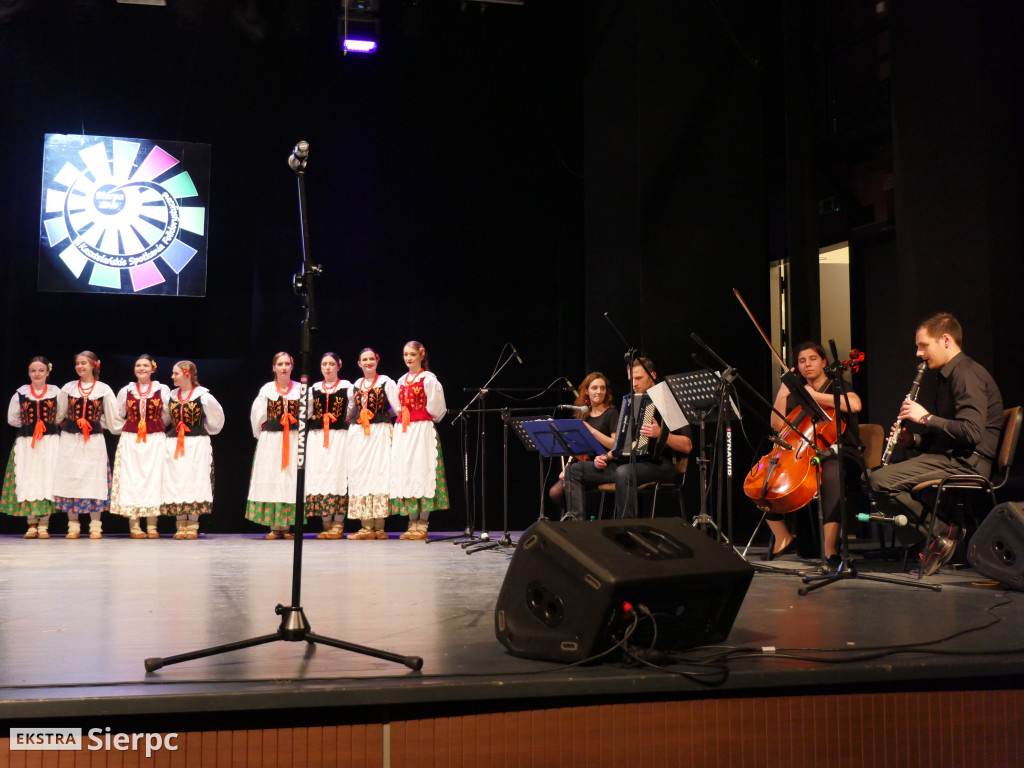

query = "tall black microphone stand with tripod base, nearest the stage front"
145;141;423;672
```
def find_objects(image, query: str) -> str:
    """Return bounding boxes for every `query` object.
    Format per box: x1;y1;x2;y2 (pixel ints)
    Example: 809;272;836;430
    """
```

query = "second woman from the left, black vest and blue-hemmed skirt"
53;350;123;539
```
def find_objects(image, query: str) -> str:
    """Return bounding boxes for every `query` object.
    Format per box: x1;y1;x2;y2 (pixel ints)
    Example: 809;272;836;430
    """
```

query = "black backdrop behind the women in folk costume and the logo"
0;0;584;530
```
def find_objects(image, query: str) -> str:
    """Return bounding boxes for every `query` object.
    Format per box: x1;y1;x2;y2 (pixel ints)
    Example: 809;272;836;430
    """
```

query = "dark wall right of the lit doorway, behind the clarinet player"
863;0;1024;462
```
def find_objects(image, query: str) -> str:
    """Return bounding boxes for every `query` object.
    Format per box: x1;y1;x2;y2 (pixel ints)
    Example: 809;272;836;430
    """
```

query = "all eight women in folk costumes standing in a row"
0;341;449;541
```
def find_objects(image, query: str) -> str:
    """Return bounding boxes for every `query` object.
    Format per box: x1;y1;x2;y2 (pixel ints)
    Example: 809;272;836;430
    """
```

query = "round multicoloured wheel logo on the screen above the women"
43;136;206;292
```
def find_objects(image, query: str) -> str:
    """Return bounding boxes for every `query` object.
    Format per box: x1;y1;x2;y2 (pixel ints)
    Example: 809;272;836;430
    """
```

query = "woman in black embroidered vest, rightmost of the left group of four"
160;360;224;539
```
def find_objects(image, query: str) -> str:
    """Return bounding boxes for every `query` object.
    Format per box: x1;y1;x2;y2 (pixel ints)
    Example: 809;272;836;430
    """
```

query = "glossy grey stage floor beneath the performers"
0;535;1024;721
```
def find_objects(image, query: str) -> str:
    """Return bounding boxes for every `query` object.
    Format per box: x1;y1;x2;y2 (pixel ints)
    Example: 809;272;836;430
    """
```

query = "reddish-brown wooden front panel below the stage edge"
0;690;1024;768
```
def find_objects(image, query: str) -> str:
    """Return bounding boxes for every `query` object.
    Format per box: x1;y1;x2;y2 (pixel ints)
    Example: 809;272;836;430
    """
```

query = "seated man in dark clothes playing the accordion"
565;357;693;520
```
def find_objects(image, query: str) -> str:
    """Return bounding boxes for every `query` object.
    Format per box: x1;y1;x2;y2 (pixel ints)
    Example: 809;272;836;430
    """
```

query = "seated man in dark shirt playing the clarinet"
870;312;1002;575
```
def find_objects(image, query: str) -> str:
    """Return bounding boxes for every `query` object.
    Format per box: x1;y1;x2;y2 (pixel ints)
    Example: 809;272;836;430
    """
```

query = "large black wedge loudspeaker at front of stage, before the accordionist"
495;518;754;663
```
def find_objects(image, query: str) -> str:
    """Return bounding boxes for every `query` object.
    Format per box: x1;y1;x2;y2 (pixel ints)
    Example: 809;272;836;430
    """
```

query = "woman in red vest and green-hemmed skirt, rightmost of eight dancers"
389;341;449;540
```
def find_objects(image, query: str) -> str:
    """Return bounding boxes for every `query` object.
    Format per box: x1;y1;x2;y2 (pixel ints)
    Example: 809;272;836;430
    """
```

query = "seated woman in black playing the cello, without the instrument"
765;341;864;569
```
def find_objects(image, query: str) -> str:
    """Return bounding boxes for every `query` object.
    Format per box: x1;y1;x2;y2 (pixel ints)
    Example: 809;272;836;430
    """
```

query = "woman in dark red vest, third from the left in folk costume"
111;354;171;539
